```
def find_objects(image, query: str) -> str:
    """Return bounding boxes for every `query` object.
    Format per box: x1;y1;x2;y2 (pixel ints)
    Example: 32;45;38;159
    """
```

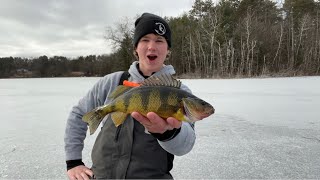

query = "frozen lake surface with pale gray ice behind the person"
0;77;320;179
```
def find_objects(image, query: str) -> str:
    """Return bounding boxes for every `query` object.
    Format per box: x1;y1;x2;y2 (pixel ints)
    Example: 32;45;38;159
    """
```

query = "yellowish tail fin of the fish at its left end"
82;109;105;135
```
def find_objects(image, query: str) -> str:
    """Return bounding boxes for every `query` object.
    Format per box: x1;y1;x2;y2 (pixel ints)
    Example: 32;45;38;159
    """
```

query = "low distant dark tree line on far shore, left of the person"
0;55;125;78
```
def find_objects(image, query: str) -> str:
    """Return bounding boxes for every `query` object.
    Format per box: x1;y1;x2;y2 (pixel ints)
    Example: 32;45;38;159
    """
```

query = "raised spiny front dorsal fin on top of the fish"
141;74;181;88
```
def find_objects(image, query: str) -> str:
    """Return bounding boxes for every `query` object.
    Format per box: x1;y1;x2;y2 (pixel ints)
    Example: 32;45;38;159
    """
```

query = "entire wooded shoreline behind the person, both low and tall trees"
0;0;320;78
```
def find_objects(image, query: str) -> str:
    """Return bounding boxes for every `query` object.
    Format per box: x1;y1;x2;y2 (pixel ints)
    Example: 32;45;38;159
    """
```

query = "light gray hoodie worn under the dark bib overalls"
64;61;196;161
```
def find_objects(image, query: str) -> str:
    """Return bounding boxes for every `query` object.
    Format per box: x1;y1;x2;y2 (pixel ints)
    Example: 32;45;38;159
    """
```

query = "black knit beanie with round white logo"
133;13;171;48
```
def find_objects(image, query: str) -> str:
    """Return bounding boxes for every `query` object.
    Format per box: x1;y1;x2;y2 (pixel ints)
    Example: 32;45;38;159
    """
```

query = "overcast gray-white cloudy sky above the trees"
0;0;194;57
